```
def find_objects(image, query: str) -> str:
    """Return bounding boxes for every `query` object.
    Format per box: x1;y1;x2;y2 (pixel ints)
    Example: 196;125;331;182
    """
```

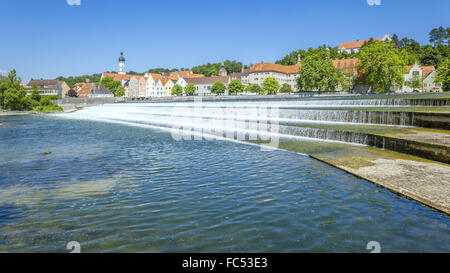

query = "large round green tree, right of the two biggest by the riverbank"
358;41;407;93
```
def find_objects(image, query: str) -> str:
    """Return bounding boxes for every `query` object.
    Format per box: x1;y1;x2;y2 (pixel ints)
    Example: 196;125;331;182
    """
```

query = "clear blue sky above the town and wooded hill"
0;0;450;82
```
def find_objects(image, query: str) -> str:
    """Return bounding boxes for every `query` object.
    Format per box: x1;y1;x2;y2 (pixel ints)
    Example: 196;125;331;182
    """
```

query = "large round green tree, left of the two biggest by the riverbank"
297;49;344;91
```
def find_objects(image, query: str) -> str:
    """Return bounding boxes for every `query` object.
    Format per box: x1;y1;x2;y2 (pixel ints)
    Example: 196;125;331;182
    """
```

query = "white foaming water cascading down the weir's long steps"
60;96;450;149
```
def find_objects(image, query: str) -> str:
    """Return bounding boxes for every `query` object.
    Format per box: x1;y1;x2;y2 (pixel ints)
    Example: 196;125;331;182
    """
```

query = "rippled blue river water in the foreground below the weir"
0;116;450;252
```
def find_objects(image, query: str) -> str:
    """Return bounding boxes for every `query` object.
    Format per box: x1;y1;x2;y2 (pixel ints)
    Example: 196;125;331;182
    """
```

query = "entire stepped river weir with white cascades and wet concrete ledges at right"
56;94;450;213
